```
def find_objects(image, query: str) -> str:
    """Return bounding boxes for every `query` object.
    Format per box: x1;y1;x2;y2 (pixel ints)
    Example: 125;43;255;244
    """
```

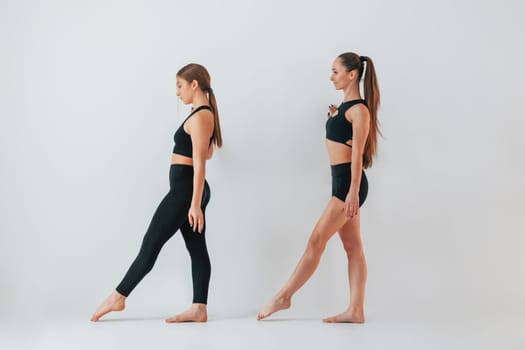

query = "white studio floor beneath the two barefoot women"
4;313;525;350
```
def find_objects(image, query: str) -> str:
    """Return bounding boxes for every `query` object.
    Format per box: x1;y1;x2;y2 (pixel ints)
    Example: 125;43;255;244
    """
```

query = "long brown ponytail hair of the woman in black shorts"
338;52;381;168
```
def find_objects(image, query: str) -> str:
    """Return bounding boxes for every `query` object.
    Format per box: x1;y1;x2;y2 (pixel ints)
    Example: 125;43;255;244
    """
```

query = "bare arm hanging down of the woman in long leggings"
188;111;213;233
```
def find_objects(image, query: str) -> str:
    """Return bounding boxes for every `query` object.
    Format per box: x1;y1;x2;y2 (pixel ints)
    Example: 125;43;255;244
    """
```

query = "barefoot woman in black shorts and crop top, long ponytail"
257;52;379;323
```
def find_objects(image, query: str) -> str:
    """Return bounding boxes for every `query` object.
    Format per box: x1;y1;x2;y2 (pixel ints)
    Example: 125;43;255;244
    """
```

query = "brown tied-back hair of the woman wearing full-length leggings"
177;63;222;148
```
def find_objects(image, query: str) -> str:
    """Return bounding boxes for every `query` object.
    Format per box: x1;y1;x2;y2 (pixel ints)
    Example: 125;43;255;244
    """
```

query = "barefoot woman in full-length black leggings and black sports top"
91;63;222;322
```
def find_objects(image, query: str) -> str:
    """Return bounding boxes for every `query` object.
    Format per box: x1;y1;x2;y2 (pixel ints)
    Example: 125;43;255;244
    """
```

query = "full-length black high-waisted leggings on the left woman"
117;164;211;304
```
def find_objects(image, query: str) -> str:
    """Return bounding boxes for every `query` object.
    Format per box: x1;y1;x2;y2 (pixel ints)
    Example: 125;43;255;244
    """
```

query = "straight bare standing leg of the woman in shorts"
323;214;366;323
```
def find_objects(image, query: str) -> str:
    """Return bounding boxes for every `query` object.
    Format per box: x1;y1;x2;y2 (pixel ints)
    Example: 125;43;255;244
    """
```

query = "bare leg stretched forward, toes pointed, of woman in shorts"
257;198;347;320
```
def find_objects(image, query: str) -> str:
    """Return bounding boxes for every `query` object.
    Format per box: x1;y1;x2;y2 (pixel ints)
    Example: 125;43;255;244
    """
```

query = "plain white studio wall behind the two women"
0;0;525;320
